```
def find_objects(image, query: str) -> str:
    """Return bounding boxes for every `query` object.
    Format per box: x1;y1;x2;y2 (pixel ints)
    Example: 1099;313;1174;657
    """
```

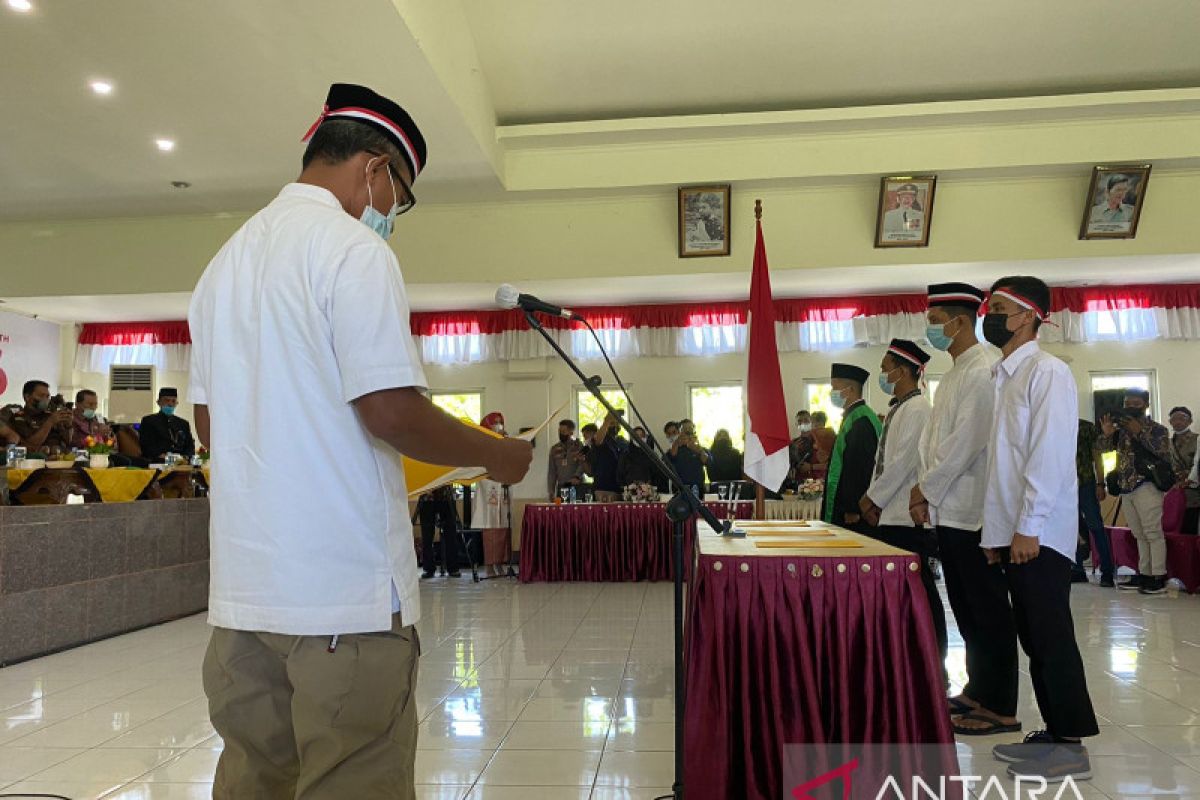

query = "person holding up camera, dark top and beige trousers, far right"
1099;389;1175;595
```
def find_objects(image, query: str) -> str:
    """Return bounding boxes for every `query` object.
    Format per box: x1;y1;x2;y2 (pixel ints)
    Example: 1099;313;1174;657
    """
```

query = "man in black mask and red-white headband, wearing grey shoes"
982;276;1099;782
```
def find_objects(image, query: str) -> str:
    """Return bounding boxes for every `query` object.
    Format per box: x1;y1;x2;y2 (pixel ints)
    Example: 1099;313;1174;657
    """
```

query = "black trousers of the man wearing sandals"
937;525;1018;717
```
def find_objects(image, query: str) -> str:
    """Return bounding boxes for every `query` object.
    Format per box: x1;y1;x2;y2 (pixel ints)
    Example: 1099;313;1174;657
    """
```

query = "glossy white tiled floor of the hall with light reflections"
0;579;1200;800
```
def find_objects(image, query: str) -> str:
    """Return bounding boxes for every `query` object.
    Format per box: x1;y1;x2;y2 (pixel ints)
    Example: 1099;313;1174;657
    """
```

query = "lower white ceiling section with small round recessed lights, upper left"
0;0;497;219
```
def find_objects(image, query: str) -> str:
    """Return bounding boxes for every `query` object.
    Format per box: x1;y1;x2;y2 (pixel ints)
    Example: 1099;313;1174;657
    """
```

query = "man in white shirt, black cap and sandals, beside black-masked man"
910;283;1021;736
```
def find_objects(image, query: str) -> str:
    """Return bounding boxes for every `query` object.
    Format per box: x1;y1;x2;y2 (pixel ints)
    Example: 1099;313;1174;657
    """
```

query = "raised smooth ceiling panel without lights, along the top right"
464;0;1200;124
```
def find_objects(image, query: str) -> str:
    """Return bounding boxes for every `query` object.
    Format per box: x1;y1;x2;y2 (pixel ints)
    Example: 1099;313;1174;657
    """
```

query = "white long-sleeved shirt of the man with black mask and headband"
982;342;1079;561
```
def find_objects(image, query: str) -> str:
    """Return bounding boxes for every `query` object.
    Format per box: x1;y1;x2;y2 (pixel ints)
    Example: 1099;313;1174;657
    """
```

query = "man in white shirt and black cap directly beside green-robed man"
859;339;949;684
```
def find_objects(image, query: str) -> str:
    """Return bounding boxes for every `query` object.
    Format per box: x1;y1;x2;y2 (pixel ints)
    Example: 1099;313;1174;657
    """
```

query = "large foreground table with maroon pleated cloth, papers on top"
684;523;956;800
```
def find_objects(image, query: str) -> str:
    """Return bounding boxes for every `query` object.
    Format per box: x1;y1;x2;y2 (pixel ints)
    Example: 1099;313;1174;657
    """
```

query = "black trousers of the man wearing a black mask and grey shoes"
1001;547;1100;739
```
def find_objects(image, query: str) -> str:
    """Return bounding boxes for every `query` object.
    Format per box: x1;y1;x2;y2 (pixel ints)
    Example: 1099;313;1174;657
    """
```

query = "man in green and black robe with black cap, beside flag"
823;363;883;531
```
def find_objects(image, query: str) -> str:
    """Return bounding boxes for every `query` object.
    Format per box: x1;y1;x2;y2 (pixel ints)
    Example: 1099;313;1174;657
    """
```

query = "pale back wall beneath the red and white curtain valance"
65;342;1200;498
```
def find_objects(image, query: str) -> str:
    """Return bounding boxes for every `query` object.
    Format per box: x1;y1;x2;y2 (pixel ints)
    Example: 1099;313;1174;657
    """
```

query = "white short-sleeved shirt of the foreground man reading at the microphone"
188;184;425;636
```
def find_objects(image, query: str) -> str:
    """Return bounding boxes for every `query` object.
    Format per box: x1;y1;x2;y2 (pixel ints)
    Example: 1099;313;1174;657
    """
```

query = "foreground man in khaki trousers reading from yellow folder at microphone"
188;84;532;799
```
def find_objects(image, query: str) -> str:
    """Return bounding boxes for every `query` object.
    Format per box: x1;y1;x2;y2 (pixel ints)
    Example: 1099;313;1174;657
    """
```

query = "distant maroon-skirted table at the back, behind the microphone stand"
521;501;754;583
